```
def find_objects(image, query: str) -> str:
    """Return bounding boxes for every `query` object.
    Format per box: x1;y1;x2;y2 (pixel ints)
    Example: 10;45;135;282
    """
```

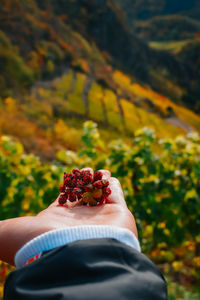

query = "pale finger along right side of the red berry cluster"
108;177;127;207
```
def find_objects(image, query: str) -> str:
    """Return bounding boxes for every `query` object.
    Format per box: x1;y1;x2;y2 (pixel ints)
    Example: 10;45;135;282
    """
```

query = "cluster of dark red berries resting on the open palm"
58;169;111;206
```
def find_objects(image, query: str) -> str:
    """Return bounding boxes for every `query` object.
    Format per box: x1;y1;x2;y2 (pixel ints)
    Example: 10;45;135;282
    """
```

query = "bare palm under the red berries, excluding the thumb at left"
37;173;137;236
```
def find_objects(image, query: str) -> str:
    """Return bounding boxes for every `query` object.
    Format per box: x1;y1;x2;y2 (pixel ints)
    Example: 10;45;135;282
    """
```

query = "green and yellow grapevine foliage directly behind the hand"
0;121;200;300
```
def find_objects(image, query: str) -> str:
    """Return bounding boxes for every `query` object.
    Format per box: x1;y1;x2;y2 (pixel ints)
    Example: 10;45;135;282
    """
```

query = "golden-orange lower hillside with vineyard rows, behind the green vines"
0;68;200;162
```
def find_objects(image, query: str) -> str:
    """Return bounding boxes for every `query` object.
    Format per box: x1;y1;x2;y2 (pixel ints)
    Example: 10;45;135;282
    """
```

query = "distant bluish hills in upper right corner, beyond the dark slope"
117;0;200;110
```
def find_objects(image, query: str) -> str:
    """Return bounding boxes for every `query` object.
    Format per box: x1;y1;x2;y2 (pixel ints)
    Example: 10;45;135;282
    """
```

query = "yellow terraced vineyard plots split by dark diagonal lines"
30;69;200;137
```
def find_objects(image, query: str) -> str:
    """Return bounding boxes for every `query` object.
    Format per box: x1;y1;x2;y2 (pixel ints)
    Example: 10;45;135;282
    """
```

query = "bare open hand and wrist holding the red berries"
0;169;137;264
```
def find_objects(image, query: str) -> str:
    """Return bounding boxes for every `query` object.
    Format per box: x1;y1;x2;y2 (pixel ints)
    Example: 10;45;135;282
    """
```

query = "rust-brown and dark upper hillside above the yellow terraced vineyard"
0;0;199;107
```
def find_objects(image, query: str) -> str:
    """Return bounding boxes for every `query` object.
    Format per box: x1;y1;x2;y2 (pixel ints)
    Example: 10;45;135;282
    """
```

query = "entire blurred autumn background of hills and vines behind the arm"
0;0;200;300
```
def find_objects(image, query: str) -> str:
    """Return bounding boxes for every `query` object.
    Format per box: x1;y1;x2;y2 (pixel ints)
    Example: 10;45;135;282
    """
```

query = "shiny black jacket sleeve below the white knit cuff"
4;238;167;300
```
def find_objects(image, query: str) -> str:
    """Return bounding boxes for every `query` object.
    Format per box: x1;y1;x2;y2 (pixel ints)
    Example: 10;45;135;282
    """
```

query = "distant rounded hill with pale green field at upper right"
133;15;200;85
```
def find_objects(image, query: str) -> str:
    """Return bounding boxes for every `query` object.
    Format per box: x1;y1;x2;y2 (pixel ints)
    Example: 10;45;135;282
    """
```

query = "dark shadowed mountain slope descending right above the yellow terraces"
49;0;200;106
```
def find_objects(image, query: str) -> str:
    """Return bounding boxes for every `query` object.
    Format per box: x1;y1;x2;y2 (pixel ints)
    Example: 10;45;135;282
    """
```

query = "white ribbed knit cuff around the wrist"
15;225;141;267
